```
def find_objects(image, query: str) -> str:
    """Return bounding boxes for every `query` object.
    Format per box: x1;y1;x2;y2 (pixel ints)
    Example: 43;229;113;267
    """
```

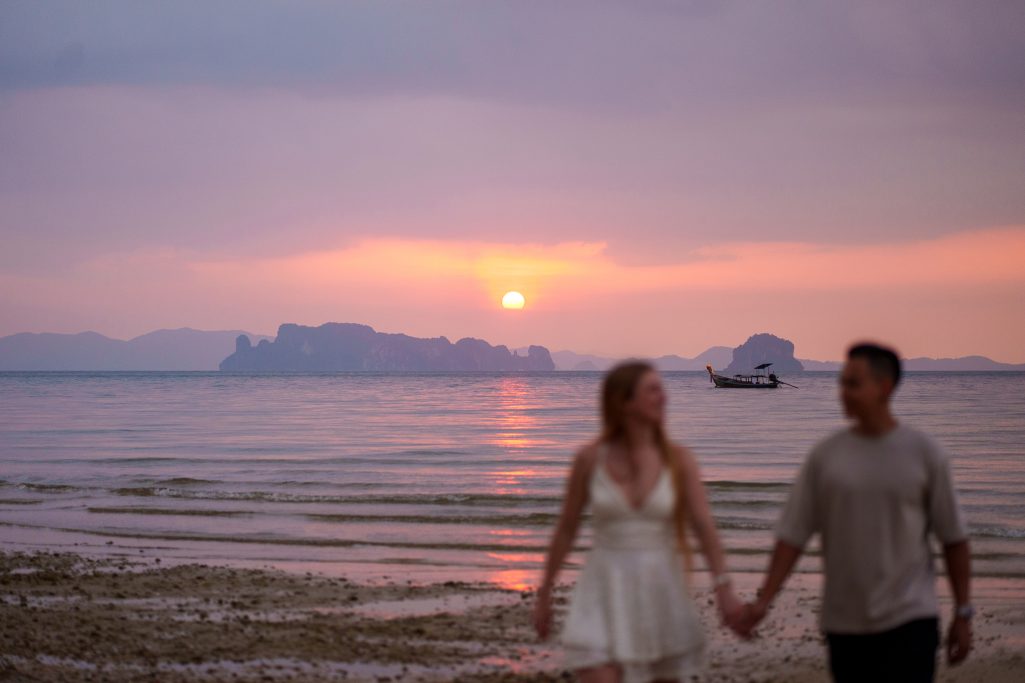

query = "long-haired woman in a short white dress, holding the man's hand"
534;361;743;683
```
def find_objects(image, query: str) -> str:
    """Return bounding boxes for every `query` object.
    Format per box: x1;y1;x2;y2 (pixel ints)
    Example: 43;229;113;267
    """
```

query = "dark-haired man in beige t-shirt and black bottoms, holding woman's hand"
737;344;973;683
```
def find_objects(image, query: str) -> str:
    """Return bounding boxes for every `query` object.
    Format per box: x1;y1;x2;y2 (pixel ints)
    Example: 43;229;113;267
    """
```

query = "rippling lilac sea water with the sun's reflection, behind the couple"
0;372;1025;587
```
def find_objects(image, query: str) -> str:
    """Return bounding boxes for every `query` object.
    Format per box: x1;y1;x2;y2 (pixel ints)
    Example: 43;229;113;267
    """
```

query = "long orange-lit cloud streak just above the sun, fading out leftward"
49;227;1025;309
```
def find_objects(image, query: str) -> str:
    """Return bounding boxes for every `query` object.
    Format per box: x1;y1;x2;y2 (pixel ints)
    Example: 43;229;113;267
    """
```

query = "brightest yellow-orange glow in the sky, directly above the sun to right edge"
186;228;1025;300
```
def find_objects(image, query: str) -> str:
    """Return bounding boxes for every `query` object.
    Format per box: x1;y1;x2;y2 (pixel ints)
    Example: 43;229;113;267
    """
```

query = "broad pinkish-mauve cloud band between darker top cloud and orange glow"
6;81;1025;271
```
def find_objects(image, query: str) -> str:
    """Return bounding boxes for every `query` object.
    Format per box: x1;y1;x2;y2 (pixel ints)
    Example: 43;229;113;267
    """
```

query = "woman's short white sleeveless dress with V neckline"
562;445;704;683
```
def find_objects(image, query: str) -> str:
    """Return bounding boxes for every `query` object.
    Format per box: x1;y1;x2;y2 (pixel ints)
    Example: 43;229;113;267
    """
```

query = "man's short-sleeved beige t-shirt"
776;425;968;634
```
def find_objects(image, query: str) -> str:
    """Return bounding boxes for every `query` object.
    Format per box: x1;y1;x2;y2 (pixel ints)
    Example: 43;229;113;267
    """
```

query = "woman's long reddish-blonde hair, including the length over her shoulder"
602;360;691;571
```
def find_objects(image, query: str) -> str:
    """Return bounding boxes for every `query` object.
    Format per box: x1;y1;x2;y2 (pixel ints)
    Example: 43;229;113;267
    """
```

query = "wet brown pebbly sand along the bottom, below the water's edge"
0;553;1025;683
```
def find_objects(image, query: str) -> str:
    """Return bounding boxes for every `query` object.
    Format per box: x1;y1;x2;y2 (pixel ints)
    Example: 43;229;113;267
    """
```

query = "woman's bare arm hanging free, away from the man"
534;446;597;640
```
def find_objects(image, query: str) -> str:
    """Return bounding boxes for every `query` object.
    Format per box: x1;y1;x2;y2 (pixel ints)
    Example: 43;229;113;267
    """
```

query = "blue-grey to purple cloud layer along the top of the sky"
0;0;1025;111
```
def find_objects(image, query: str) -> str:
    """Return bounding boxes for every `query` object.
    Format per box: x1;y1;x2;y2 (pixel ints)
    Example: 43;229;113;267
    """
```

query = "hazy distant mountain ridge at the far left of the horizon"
0;327;269;370
